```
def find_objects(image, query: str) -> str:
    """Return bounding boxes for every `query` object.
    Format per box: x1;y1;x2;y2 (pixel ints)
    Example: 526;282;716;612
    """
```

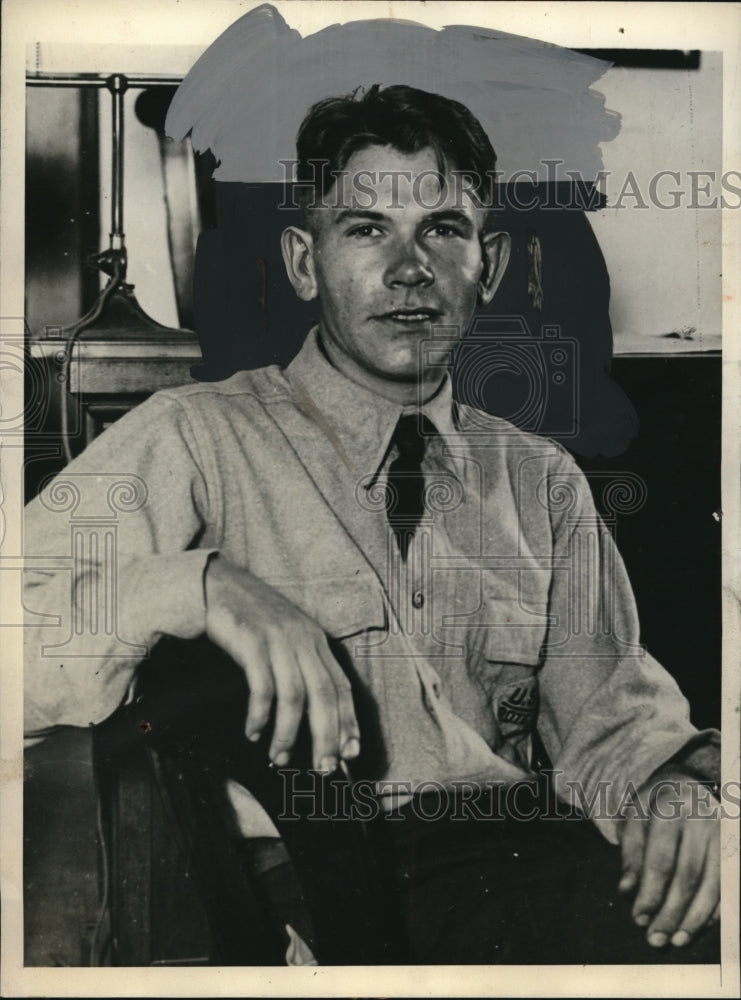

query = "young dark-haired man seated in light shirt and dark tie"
25;86;719;964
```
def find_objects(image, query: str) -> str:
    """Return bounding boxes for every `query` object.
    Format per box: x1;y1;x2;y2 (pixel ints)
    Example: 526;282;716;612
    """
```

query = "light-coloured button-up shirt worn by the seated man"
24;331;712;839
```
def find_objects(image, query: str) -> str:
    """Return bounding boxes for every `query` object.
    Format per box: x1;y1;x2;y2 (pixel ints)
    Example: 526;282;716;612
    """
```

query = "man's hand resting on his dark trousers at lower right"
618;770;720;948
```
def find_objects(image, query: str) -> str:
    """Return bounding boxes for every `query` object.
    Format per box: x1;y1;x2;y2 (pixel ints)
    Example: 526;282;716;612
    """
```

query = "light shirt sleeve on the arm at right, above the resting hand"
538;453;719;842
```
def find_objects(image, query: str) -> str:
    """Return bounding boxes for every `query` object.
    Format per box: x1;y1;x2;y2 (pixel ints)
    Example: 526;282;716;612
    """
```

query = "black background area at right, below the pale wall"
576;355;722;727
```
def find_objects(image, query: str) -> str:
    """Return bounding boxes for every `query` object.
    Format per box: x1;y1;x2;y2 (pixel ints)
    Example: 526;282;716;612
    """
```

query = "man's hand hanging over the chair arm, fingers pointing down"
205;555;360;773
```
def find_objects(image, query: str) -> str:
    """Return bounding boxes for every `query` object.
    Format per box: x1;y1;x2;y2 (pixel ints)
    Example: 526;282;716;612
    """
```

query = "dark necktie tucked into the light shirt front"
386;413;435;559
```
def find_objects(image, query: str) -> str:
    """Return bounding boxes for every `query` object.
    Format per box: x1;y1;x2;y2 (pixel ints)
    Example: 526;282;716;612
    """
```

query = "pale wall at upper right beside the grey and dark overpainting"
589;52;720;353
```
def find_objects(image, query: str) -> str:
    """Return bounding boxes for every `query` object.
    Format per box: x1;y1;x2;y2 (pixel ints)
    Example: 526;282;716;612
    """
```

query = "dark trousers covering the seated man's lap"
376;784;720;965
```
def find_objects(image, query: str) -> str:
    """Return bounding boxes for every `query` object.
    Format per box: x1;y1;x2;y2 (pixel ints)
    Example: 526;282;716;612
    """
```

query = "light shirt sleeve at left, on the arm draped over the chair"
24;394;213;737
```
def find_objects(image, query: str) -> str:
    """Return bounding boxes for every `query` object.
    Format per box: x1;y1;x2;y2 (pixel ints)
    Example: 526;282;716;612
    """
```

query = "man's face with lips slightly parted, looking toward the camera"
289;146;508;398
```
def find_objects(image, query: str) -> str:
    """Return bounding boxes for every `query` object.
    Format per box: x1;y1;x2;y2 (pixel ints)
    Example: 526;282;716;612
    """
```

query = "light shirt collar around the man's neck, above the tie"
286;327;456;479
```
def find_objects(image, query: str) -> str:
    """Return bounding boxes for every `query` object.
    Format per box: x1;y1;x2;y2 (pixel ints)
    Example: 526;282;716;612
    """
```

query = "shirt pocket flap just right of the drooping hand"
266;573;388;639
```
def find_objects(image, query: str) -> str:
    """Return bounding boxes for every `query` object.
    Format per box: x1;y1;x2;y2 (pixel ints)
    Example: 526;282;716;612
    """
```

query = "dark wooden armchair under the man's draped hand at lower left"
95;638;400;965
